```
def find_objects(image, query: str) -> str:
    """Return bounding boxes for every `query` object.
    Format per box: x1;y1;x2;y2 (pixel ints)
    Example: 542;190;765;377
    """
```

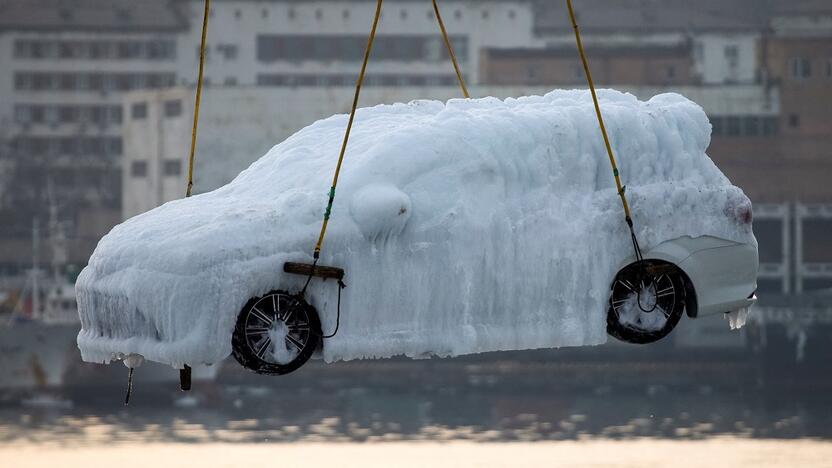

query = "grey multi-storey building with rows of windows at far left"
0;0;187;275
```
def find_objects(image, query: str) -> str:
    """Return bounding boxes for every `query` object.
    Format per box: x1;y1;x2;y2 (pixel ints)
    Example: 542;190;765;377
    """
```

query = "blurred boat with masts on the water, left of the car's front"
0;210;220;394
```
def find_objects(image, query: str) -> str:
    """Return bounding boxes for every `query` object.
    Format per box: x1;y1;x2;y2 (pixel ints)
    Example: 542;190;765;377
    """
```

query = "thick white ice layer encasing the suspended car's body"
77;87;753;366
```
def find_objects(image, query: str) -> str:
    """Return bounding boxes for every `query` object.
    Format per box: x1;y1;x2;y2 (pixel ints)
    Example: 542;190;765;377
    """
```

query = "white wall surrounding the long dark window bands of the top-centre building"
178;0;535;85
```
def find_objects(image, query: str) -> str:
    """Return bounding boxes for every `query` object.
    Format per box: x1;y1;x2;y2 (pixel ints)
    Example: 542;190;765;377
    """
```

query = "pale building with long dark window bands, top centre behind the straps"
172;0;535;87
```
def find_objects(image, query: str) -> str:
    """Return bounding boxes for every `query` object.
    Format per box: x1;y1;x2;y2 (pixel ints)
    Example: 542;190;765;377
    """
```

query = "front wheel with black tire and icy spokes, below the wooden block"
231;291;322;375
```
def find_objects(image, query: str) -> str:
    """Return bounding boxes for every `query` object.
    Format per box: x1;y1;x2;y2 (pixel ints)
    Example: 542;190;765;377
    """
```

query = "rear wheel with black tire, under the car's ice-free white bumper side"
607;260;686;344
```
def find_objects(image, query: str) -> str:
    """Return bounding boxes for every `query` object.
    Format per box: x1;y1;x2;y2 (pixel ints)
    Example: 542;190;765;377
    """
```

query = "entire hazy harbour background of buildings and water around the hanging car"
0;0;832;466
